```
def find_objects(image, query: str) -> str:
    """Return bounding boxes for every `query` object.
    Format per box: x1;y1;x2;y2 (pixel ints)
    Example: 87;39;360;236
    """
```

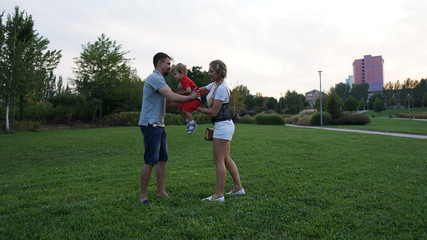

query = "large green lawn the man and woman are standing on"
0;124;427;239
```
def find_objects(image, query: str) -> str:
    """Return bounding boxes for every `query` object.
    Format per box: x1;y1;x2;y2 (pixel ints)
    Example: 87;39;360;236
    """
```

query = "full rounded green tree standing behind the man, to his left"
74;34;135;119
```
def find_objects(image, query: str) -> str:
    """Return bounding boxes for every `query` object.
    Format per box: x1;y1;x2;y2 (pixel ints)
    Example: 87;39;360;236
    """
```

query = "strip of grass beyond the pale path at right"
327;117;427;134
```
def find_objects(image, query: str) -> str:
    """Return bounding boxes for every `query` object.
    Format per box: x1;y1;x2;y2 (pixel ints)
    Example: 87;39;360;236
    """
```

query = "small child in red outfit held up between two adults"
171;63;202;134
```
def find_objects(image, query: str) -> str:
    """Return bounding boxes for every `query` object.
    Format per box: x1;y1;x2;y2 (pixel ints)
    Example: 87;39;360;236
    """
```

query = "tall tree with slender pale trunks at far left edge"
0;7;61;132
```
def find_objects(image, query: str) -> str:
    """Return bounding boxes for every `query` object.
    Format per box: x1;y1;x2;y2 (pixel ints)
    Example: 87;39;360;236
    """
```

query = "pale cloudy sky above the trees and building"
0;0;427;98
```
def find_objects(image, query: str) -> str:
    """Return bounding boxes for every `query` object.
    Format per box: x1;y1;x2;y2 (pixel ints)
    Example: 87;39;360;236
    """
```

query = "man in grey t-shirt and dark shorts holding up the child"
139;52;199;205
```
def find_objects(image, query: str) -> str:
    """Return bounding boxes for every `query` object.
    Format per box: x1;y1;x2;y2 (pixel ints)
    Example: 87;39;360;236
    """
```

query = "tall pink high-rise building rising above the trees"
353;55;384;92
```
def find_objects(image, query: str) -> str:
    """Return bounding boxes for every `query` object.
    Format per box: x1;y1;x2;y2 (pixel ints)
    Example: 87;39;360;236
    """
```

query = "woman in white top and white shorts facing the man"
196;60;246;202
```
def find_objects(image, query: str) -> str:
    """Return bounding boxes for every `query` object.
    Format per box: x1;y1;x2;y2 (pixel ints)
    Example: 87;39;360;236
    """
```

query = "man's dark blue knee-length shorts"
141;125;168;165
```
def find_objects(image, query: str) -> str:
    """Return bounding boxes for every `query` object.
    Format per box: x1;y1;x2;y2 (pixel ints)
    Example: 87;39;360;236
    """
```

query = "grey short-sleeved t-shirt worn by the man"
138;70;168;127
